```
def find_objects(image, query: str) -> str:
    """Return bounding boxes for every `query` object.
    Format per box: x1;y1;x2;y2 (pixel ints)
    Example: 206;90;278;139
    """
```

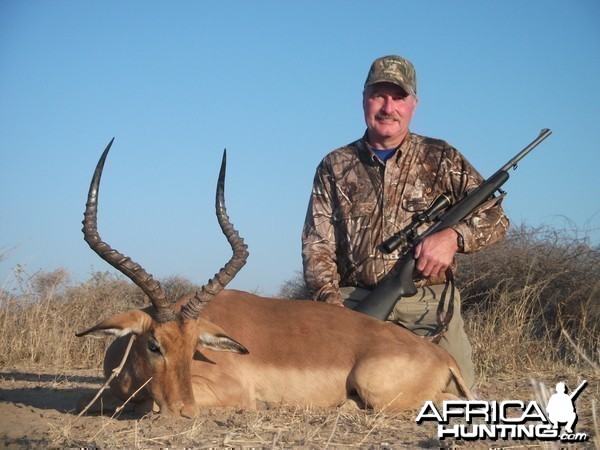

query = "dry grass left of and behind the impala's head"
0;268;197;370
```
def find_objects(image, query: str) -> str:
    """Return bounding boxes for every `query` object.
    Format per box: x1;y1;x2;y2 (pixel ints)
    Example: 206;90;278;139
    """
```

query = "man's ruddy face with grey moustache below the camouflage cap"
363;83;419;148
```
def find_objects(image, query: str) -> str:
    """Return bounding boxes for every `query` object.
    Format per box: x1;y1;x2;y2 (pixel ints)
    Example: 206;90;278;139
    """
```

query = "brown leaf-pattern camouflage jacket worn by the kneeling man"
302;133;509;303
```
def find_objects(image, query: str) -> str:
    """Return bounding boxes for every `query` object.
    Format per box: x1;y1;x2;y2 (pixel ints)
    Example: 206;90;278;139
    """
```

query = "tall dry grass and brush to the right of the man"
459;223;600;380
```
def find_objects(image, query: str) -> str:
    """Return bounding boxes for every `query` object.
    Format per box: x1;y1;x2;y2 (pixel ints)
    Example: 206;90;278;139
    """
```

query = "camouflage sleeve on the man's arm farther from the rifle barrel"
302;163;342;303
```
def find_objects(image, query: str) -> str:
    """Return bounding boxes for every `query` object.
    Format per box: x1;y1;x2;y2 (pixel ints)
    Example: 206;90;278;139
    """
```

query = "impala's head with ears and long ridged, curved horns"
77;139;248;417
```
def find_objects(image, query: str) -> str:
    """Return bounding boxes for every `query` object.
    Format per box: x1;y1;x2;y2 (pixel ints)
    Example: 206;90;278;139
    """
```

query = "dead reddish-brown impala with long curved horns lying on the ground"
77;141;473;417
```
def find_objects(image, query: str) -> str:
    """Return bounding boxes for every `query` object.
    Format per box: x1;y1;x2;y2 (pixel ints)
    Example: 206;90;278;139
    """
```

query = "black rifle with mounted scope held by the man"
354;128;552;320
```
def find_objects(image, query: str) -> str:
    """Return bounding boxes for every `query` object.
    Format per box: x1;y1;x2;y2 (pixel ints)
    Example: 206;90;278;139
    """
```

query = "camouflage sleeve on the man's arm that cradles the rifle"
447;149;509;253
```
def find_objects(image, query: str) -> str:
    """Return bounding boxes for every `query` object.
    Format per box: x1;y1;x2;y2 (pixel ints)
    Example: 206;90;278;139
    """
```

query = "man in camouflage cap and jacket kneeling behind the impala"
302;55;509;387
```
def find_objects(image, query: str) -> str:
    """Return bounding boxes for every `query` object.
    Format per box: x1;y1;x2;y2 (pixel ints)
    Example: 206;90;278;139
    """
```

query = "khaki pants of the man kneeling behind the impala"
340;285;475;388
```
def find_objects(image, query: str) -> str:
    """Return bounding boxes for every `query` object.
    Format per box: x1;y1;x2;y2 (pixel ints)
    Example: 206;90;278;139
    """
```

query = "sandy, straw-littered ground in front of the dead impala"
0;368;598;449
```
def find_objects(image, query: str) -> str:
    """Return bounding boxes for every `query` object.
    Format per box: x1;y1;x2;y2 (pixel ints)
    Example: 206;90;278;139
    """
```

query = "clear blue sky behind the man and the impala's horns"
0;0;600;294
